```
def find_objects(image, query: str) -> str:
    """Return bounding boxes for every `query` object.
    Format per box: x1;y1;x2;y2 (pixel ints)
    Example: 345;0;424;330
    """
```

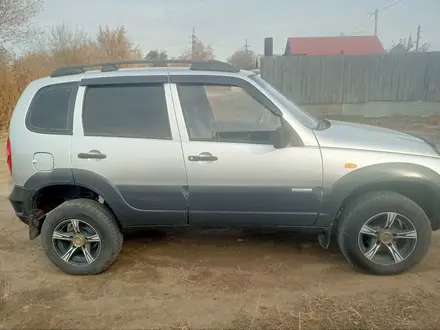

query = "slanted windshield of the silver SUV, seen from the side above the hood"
249;75;319;129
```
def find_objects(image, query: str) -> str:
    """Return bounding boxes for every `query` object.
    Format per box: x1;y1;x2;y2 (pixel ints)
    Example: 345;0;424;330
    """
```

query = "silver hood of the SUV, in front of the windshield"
315;120;439;157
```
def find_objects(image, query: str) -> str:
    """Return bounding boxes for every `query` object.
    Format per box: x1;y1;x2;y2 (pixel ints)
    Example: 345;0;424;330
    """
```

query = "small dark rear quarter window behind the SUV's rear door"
26;83;78;135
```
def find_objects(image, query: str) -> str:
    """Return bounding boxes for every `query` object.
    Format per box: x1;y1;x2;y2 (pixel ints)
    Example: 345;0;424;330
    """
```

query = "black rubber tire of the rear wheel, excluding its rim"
41;199;123;275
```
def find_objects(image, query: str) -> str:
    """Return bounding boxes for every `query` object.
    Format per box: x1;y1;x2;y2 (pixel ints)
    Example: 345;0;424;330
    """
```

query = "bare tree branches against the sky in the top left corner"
0;0;42;47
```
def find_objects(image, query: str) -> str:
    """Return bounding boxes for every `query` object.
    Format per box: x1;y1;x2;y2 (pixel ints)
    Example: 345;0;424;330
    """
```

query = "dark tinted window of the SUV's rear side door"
83;84;171;139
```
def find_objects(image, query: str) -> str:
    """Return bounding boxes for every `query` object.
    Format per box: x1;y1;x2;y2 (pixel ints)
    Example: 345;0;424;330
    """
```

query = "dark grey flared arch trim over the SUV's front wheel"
318;163;440;230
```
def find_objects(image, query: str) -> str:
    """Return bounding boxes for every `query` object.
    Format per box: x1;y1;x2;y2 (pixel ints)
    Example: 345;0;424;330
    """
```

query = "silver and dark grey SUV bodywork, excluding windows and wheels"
9;68;440;233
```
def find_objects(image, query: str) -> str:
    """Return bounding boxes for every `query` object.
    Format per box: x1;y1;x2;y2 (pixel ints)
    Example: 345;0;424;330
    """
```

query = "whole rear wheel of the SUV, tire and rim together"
41;199;123;275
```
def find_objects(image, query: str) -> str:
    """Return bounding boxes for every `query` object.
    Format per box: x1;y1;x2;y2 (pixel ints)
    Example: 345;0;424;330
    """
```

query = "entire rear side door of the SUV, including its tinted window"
70;76;188;227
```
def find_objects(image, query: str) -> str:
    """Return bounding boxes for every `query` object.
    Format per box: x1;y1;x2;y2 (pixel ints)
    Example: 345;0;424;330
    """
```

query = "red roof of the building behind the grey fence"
286;36;385;55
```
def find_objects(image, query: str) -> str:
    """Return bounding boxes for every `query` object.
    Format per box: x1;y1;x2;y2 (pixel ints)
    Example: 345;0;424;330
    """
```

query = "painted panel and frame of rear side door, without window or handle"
71;86;188;226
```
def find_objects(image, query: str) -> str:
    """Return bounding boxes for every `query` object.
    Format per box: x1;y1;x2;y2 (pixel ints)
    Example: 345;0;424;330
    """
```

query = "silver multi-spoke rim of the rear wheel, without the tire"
52;219;101;265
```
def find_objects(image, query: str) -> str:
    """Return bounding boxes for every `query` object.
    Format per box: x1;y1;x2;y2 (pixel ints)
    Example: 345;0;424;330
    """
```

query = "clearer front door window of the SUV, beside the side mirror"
178;84;281;144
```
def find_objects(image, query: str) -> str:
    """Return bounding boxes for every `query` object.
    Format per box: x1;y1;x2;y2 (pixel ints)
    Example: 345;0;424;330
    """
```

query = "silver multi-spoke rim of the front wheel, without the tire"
358;212;417;266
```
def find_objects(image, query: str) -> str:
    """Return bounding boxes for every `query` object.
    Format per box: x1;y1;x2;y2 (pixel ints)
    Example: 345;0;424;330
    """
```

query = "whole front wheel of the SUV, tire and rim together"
337;191;432;275
